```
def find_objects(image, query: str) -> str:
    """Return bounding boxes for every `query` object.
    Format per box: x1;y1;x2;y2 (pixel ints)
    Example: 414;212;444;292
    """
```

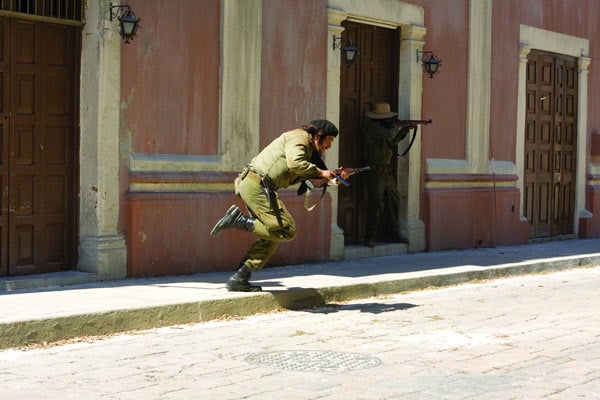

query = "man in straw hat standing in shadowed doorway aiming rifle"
363;102;414;247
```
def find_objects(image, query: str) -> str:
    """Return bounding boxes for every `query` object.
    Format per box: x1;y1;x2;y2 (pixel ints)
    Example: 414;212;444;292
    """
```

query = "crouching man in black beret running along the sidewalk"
210;119;347;292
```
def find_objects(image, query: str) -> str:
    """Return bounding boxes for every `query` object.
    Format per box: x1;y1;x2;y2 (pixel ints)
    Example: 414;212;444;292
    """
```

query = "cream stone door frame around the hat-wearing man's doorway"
326;0;427;260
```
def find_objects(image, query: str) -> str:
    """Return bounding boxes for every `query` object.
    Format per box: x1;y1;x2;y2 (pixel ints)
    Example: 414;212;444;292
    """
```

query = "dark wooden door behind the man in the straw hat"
338;21;400;244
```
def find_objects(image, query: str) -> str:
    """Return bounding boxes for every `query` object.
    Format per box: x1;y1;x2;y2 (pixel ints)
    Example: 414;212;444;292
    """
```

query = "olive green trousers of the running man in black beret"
235;172;296;270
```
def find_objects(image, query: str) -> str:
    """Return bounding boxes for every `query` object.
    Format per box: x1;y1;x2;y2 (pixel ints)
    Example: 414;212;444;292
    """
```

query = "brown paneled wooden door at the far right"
523;50;578;239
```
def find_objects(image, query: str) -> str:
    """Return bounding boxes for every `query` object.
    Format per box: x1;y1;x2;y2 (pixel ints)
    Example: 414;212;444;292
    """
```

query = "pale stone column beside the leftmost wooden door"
78;0;126;279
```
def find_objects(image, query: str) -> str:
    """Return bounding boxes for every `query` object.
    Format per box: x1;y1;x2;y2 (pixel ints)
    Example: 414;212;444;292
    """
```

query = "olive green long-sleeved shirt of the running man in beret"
250;129;321;189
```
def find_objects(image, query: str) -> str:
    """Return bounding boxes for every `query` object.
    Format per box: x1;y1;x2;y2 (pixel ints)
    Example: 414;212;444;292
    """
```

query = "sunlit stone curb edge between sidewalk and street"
0;256;600;349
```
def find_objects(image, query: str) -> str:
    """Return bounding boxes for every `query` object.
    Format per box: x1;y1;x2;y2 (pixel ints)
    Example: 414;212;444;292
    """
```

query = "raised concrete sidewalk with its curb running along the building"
0;239;600;349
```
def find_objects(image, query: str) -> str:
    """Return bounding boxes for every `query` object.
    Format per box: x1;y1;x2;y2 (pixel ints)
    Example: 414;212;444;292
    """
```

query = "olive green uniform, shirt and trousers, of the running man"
235;129;321;270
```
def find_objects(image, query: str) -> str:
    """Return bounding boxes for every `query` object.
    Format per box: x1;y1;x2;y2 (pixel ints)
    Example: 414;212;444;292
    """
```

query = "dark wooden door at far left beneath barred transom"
0;18;79;275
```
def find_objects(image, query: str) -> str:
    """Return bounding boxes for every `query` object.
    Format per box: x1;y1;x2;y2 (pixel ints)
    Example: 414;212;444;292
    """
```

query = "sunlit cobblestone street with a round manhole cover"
0;267;600;400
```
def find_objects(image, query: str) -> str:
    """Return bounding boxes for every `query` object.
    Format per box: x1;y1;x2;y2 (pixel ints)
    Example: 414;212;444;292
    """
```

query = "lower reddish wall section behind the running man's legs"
127;192;331;277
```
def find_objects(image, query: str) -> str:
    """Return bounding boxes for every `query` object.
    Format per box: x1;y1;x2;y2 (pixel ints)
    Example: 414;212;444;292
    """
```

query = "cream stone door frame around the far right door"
515;25;592;237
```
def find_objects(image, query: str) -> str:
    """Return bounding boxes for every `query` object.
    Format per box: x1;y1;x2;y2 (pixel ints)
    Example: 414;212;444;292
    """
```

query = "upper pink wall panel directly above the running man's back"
260;0;329;148
